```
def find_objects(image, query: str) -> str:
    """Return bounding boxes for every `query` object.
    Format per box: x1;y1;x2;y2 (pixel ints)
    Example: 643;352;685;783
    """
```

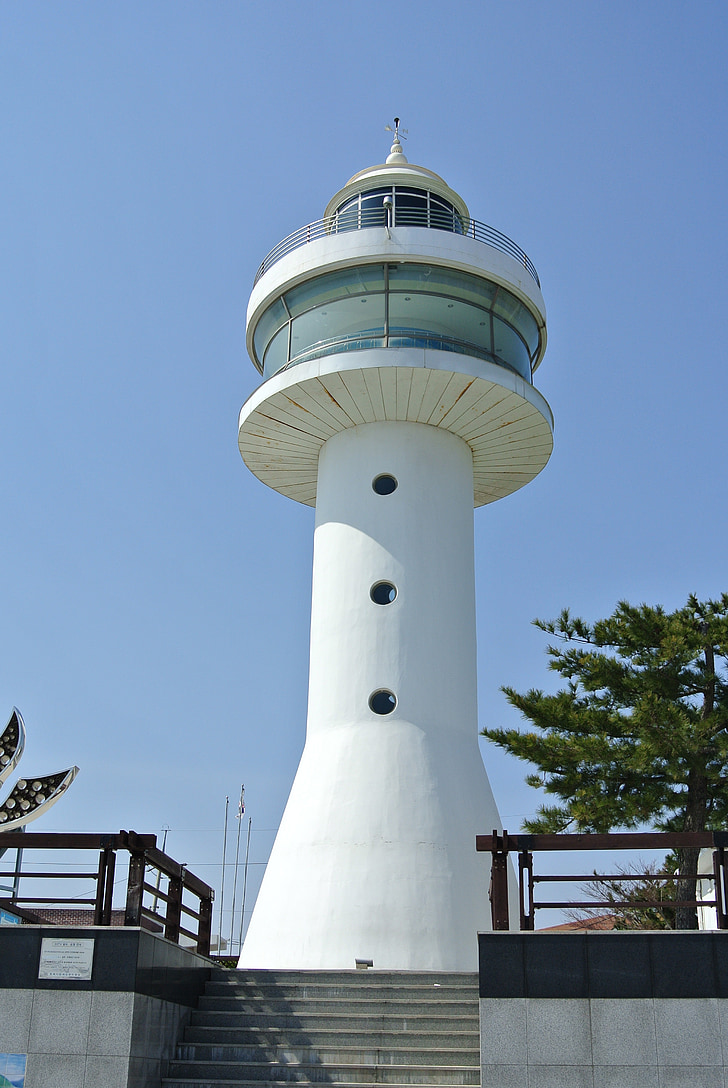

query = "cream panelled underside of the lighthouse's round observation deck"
239;366;553;506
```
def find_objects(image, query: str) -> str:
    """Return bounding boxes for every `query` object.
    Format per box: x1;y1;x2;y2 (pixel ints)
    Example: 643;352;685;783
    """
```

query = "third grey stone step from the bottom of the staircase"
180;1024;480;1052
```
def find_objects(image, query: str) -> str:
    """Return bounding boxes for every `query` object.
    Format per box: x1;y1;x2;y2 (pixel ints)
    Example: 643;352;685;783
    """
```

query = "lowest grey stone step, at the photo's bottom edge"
165;1061;480;1085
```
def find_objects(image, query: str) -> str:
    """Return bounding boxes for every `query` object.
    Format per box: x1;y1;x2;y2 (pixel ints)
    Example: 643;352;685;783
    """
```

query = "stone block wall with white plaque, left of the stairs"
0;926;210;1088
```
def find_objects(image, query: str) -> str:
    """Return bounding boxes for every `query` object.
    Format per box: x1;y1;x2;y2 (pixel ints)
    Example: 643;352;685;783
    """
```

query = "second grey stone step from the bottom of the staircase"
177;1039;479;1067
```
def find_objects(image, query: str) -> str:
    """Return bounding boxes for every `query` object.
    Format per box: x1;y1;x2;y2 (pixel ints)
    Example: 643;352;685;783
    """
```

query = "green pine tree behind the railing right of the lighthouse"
482;593;728;929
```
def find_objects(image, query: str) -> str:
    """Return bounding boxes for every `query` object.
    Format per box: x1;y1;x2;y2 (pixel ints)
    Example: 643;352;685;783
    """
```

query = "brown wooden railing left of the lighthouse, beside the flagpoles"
0;831;214;955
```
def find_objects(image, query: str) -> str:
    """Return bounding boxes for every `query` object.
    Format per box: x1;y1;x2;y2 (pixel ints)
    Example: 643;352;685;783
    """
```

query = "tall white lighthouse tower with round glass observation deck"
239;125;553;970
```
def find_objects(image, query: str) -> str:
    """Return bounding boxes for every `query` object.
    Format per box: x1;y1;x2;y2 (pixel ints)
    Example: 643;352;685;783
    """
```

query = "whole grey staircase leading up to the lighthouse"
162;969;480;1088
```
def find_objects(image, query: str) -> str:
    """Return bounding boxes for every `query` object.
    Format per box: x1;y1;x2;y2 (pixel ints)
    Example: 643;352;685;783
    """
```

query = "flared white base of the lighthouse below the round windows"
239;721;502;970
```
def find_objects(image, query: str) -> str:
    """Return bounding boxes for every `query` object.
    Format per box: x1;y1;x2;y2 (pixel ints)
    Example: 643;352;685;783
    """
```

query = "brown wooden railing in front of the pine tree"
476;831;728;930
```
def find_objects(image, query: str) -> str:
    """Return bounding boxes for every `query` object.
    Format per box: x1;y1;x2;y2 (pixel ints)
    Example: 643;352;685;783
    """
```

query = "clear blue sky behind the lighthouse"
0;0;728;944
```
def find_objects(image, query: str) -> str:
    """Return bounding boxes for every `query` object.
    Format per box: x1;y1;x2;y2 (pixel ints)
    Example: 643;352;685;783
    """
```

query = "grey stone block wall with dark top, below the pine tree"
479;932;728;1088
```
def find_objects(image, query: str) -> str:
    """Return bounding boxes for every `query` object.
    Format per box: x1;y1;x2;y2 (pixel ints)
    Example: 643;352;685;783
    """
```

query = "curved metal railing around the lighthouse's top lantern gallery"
254;210;541;287
